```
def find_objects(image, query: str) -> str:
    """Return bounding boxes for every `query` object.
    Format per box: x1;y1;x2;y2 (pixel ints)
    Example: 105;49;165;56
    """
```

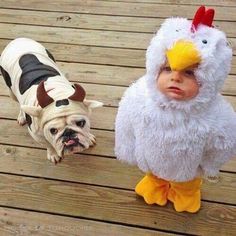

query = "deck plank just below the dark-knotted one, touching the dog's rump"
0;23;236;54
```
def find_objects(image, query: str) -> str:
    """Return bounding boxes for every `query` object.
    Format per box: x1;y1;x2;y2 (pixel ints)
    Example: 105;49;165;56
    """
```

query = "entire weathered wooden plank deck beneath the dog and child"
0;0;236;236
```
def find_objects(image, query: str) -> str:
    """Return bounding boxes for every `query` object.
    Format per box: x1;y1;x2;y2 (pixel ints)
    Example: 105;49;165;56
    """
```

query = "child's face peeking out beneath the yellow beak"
156;63;200;101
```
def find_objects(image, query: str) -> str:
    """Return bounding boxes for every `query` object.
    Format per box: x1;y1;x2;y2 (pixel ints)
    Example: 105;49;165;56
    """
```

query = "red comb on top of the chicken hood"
191;6;215;32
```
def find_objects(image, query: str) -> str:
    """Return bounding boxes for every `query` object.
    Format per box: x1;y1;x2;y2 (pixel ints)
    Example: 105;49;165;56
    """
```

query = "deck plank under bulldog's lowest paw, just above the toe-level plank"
0;145;236;204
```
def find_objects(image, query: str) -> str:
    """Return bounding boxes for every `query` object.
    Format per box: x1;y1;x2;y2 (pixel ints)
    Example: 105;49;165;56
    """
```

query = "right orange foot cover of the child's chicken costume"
167;178;202;213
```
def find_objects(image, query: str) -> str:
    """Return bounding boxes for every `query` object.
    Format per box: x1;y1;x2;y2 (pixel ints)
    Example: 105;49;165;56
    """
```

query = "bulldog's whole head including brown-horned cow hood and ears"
21;82;102;157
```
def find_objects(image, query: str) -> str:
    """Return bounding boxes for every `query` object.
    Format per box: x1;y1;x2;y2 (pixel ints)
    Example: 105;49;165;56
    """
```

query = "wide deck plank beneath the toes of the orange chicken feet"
0;174;236;235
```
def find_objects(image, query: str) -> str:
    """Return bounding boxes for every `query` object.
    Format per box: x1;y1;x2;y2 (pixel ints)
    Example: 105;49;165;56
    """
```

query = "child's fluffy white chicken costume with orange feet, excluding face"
115;6;236;212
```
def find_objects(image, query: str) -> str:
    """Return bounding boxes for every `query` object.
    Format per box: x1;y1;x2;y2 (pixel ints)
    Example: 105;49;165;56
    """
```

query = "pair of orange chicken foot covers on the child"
135;174;202;213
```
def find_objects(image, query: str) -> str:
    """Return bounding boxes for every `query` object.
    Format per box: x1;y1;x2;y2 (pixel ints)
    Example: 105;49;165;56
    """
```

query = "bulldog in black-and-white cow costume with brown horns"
0;38;102;163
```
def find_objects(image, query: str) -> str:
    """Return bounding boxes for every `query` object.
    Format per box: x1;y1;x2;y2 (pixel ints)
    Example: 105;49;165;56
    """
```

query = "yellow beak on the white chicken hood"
166;40;201;71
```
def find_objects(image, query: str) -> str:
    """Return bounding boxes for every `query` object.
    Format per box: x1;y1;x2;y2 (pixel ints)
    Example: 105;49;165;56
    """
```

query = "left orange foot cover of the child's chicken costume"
135;174;170;206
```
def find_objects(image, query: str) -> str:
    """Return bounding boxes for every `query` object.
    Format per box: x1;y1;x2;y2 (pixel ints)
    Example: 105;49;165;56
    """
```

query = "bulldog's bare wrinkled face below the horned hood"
43;114;90;157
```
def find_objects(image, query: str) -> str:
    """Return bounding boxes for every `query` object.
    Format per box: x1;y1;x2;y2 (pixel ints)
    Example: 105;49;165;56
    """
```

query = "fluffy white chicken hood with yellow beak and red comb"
146;6;232;112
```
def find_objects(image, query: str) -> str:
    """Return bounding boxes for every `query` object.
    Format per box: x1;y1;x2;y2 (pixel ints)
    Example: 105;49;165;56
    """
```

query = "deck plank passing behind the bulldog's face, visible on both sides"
0;120;114;158
